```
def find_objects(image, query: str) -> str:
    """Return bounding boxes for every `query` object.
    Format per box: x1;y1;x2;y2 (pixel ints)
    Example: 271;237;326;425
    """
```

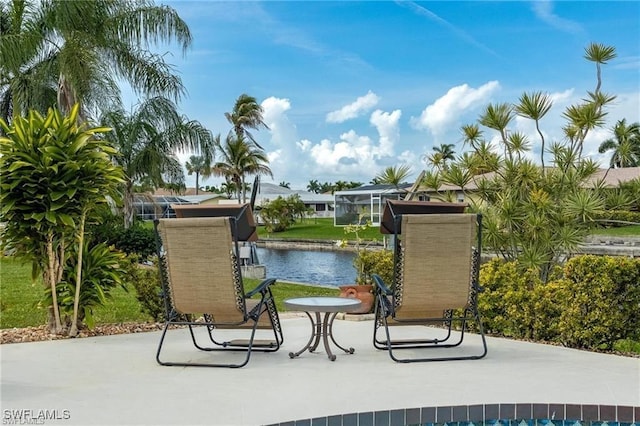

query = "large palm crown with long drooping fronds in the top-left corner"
0;0;191;123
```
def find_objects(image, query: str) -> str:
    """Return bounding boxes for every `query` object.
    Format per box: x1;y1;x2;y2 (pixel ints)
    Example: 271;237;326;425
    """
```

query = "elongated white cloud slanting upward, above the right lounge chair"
410;81;500;138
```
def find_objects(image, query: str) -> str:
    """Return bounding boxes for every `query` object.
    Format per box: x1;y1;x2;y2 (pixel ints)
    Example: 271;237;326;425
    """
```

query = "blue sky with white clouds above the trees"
149;1;640;189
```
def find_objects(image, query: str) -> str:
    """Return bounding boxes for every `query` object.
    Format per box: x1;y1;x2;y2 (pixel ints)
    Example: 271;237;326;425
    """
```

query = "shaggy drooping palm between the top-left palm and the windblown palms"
100;97;216;228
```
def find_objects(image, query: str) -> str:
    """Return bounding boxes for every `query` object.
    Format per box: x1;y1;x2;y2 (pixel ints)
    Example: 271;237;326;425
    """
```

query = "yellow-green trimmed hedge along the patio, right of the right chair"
478;255;640;350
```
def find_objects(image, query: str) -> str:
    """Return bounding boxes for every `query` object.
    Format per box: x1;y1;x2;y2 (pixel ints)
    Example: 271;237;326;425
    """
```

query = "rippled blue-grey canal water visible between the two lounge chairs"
256;247;356;286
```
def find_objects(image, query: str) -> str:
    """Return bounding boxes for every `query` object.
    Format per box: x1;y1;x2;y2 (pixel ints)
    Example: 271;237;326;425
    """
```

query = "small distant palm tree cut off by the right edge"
598;118;640;168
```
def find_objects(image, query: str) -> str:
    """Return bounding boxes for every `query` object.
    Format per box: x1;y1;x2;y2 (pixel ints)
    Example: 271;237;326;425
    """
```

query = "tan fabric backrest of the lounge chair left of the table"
157;217;246;323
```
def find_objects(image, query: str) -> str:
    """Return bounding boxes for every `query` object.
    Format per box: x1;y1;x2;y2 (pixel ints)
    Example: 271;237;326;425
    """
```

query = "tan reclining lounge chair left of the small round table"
155;217;284;367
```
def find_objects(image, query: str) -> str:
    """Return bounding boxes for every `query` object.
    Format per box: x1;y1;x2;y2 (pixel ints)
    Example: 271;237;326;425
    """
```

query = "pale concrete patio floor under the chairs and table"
0;317;640;425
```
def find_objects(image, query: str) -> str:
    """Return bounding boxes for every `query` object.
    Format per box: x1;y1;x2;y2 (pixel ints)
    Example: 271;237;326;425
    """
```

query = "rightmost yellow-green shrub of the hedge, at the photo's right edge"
556;256;640;350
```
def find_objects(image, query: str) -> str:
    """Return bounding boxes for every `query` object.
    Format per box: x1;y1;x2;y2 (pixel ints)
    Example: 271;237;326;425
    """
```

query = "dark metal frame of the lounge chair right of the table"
373;213;487;363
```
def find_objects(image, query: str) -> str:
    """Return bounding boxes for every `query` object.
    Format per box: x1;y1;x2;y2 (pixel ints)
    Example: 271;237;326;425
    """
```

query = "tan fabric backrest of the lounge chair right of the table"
394;213;477;319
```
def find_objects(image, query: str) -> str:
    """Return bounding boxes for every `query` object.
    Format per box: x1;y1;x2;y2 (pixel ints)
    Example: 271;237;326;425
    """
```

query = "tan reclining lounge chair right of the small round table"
373;208;487;362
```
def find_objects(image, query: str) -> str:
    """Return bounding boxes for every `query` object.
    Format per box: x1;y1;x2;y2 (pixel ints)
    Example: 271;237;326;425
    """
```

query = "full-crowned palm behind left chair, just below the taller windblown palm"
211;134;273;203
